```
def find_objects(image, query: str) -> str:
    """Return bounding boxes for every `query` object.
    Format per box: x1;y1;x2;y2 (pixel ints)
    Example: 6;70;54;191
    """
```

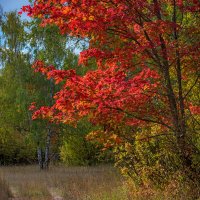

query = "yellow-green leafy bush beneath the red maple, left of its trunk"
113;126;199;188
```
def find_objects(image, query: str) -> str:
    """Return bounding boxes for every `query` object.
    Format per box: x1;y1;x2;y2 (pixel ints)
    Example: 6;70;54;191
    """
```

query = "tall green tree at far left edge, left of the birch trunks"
0;12;36;164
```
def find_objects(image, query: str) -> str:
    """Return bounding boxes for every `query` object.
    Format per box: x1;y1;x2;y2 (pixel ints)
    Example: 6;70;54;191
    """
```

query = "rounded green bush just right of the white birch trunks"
60;119;106;165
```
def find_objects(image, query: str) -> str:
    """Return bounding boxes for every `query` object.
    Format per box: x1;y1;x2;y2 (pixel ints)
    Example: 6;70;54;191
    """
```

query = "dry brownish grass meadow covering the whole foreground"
0;166;200;200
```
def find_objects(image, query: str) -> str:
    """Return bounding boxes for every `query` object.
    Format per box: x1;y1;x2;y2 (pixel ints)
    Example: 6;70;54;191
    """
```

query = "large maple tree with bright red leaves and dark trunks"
22;0;200;172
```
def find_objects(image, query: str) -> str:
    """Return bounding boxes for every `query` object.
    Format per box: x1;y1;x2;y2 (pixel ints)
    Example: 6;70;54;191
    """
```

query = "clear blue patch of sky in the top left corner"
0;0;29;19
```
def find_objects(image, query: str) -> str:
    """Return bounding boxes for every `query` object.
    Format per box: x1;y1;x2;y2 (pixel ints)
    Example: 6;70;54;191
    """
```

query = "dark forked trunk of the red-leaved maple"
153;0;192;168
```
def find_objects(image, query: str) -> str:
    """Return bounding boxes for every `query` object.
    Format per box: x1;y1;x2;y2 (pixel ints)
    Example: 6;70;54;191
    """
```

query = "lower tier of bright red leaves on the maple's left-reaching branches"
31;61;162;128
